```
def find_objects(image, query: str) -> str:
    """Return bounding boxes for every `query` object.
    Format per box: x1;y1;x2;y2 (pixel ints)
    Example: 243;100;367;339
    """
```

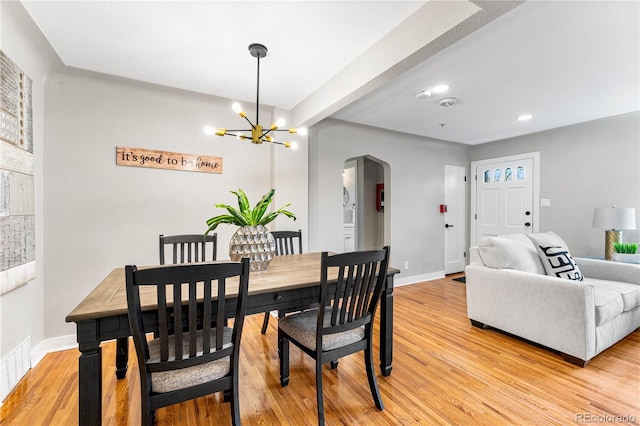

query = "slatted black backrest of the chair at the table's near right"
317;247;389;339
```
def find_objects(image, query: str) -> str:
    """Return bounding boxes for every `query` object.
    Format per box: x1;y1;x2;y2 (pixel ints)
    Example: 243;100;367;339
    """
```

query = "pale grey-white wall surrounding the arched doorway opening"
309;119;468;283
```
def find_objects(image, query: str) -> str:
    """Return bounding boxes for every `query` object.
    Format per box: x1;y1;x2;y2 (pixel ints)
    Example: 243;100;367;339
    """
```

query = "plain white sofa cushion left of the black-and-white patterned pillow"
478;234;545;275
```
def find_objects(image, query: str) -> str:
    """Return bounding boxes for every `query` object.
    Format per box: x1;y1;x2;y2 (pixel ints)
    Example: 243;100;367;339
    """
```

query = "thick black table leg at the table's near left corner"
78;342;102;426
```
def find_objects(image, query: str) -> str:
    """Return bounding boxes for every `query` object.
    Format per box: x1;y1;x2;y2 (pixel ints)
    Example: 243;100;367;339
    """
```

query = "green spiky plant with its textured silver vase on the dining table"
205;189;296;271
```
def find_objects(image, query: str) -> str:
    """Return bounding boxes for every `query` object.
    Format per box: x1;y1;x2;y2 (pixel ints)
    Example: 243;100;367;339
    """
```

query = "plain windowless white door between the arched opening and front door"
444;165;466;274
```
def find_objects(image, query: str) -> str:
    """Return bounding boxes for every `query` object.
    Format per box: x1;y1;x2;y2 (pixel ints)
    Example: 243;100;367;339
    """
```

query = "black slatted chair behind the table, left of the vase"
160;233;218;265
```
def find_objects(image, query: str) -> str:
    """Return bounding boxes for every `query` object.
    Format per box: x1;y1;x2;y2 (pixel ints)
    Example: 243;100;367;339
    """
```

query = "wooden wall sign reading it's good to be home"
116;146;222;173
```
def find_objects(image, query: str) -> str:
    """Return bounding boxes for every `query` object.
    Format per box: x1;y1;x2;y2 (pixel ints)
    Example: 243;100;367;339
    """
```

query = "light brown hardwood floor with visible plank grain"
0;277;640;426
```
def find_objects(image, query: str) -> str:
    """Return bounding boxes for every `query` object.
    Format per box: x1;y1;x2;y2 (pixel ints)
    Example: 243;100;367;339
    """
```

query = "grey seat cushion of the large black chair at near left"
149;327;233;393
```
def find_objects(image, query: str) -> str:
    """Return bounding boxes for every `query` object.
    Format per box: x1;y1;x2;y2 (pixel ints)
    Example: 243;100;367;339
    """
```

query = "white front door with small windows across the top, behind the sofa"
472;155;538;245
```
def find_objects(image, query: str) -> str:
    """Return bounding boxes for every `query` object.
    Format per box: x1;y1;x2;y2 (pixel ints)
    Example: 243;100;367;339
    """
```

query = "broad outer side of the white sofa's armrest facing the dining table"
465;265;596;361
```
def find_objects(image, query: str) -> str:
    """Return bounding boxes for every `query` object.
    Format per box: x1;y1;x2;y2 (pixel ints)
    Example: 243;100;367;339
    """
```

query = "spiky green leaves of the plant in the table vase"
205;189;296;235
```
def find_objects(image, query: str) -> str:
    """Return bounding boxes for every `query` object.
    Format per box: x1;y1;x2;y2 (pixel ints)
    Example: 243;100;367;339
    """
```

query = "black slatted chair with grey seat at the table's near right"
278;246;389;425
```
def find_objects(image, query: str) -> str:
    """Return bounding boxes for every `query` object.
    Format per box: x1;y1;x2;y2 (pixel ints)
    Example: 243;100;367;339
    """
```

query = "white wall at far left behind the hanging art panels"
0;1;58;358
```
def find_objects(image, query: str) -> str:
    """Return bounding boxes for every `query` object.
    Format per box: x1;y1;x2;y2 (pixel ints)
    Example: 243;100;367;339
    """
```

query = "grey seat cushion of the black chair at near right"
278;309;364;351
